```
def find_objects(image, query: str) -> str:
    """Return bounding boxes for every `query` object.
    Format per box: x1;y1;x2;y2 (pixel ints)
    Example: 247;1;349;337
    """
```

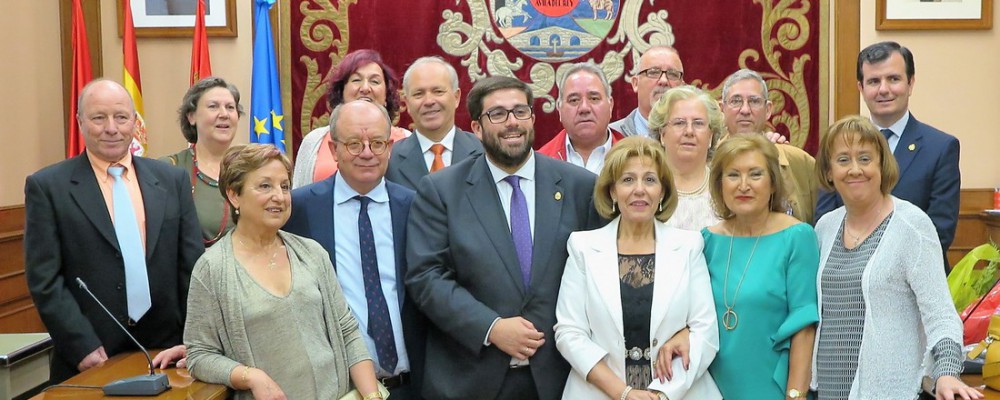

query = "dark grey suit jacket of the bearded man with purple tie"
406;153;601;400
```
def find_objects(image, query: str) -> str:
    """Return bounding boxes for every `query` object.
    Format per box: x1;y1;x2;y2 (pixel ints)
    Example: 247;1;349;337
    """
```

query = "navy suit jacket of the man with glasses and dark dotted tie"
282;174;426;393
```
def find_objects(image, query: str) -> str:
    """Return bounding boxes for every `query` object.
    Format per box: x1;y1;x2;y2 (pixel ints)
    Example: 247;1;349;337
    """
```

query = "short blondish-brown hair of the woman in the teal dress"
709;135;786;219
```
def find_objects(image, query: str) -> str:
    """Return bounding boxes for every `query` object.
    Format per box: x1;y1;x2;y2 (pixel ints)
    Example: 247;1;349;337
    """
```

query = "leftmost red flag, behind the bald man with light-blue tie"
66;0;93;158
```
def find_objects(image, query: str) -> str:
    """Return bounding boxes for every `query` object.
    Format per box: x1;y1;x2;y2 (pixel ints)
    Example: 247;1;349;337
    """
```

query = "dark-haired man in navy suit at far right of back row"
816;42;962;270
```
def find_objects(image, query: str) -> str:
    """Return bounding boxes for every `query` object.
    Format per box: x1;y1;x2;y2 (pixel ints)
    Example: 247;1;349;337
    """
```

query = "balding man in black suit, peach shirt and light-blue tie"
24;80;205;382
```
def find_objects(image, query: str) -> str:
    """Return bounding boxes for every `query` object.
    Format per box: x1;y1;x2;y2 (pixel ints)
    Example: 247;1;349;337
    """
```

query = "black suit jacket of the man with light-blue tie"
24;152;205;381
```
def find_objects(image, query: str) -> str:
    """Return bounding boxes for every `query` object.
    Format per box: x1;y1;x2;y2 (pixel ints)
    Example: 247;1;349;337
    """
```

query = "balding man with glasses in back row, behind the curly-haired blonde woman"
611;46;684;137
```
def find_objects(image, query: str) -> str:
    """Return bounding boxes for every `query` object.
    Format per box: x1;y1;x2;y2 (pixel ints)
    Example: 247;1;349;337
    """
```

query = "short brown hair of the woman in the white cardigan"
816;115;899;195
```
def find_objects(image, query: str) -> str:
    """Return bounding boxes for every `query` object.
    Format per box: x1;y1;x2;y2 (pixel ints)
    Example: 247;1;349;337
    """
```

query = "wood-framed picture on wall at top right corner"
875;0;993;30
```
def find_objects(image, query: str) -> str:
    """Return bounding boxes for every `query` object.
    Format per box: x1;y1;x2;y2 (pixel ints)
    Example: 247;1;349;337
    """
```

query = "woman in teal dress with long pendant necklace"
701;135;819;400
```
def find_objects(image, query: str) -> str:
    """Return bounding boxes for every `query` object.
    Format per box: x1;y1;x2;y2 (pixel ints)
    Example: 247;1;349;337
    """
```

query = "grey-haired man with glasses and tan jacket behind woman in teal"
719;69;819;224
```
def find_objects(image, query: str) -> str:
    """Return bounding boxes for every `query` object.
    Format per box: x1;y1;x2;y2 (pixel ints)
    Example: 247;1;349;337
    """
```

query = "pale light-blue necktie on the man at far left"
108;166;152;321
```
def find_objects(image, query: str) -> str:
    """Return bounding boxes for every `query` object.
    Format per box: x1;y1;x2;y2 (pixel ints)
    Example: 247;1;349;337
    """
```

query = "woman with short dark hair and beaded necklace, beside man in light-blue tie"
160;77;243;247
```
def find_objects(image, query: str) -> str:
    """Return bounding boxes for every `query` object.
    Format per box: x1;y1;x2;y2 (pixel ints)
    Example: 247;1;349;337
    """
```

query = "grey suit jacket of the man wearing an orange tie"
385;127;483;190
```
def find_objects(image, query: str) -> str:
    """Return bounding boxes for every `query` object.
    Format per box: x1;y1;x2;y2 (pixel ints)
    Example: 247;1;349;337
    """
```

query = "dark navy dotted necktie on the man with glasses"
354;196;399;374
